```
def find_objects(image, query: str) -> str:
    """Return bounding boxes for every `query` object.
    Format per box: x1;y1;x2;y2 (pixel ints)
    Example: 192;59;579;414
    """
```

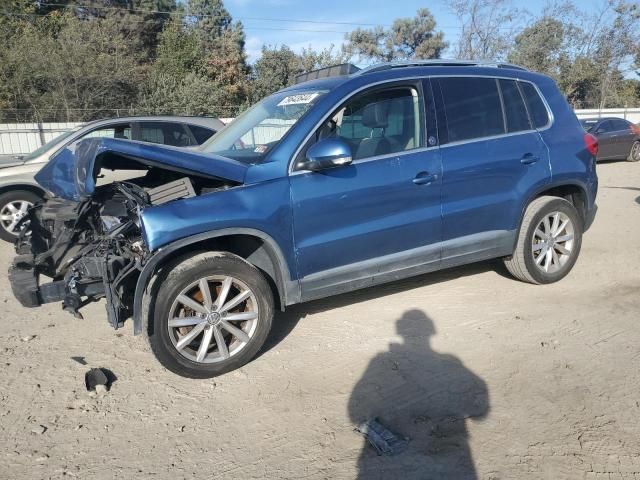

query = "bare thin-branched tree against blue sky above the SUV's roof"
449;0;525;61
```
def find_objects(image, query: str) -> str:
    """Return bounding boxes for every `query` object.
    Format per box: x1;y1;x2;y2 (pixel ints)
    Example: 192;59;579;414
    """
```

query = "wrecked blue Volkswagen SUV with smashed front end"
10;61;598;378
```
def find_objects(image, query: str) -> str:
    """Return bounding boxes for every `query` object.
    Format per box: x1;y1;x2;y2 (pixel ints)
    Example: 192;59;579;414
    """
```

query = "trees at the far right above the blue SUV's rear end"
508;0;640;108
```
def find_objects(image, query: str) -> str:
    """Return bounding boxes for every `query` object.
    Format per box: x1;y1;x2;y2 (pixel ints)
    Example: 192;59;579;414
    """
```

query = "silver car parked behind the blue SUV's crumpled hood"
0;116;224;242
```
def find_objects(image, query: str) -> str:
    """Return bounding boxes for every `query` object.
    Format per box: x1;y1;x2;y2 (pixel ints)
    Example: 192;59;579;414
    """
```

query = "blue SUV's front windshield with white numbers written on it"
201;90;325;163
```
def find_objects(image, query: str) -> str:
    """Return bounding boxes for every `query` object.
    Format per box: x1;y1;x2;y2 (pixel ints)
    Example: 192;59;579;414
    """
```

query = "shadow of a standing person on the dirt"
348;310;489;479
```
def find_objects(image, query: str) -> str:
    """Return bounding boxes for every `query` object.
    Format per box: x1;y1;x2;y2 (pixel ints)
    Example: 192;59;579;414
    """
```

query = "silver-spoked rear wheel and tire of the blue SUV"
504;196;584;284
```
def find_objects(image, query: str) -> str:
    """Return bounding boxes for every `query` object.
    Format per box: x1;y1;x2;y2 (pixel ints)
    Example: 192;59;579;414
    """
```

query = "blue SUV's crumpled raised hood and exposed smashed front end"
9;139;246;328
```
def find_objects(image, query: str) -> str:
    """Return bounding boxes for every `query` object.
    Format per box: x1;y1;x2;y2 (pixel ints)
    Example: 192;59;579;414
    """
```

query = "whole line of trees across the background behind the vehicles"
0;0;640;121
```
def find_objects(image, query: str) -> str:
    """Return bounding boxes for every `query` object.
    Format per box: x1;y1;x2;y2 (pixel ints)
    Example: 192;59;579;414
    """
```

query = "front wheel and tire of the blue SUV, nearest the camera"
149;252;274;378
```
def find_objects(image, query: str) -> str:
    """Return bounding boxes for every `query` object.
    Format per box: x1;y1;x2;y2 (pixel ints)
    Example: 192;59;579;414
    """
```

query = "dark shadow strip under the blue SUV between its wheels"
256;260;502;358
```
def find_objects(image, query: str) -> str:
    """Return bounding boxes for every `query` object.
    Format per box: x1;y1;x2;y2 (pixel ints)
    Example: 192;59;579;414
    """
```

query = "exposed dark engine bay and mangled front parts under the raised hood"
9;165;233;328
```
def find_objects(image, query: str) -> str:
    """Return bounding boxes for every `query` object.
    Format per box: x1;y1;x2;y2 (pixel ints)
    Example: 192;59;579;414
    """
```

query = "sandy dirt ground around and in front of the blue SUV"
0;162;640;479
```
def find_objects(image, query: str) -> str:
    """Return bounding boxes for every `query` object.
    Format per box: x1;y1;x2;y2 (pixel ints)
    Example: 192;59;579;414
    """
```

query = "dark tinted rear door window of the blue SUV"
439;77;505;142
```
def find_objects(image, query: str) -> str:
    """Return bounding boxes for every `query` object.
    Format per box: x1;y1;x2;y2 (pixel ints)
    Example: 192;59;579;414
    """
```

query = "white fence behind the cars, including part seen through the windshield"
0;108;640;155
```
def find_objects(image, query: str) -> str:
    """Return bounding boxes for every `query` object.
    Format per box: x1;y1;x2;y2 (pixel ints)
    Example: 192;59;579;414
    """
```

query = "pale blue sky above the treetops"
225;0;605;63
